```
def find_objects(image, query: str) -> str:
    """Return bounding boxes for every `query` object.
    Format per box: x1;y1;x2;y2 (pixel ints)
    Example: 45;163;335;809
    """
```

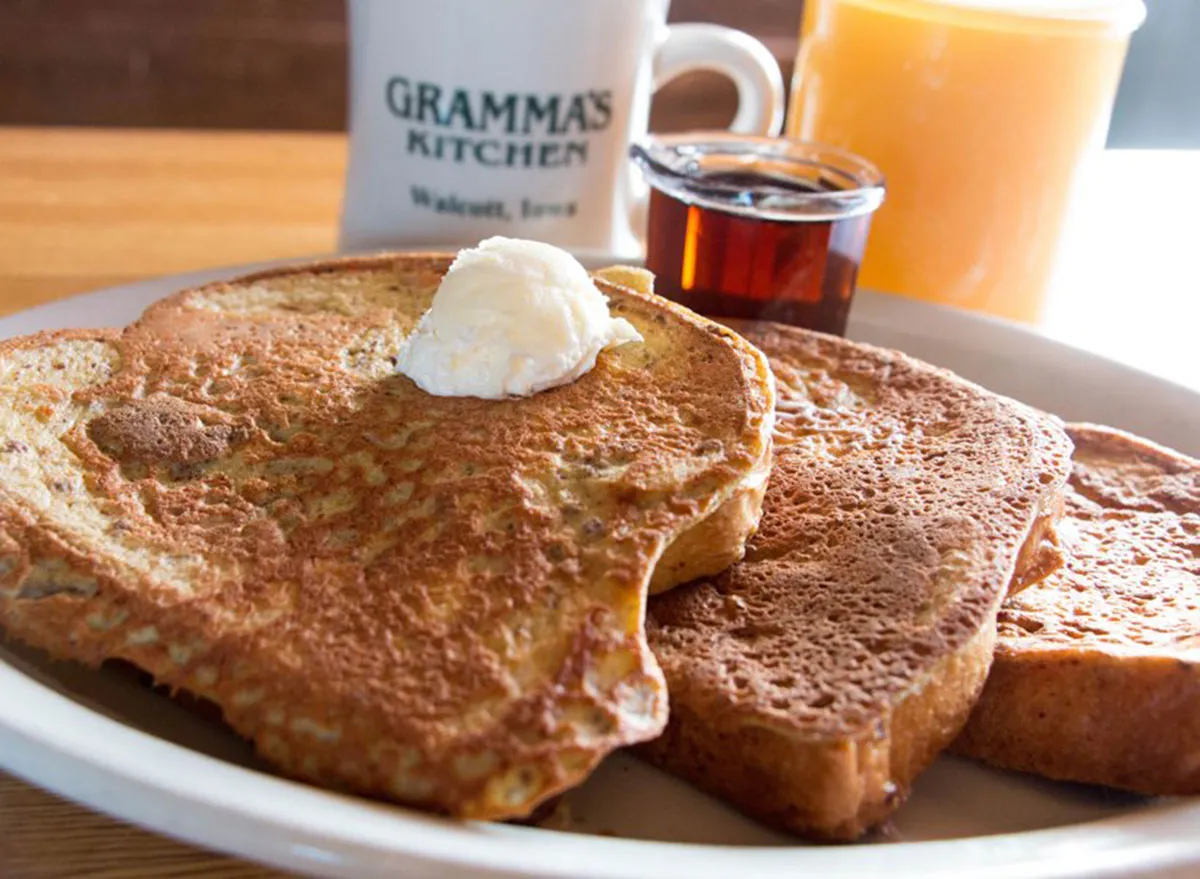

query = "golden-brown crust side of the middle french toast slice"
636;321;1069;842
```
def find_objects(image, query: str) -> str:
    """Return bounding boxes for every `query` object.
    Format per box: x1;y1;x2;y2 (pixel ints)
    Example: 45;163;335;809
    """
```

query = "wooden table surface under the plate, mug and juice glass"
0;128;1200;879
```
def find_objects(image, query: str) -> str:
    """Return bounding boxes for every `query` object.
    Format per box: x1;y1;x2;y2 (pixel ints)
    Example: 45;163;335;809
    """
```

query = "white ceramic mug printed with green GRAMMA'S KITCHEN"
341;0;784;256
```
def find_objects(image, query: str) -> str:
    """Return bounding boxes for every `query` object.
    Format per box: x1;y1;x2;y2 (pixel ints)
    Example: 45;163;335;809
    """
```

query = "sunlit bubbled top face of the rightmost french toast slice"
998;425;1200;653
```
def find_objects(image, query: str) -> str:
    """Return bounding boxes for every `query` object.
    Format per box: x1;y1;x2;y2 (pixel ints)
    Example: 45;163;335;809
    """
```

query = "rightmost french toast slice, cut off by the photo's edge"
953;424;1200;795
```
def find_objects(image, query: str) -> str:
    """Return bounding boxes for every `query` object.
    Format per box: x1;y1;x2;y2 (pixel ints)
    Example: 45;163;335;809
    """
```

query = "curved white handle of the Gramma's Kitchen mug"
629;24;784;244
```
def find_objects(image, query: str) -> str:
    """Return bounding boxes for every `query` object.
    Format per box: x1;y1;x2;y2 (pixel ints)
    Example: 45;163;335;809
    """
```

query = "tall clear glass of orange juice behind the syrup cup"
787;0;1145;322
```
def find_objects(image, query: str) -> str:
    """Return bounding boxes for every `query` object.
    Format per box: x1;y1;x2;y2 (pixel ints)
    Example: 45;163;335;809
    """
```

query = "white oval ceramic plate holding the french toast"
0;259;1200;879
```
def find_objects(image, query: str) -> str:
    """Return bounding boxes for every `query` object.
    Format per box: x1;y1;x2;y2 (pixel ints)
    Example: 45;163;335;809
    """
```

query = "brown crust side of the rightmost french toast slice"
952;424;1200;796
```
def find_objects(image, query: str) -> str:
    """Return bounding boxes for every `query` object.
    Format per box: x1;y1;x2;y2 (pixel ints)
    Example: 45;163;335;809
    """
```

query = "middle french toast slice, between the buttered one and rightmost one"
638;321;1070;841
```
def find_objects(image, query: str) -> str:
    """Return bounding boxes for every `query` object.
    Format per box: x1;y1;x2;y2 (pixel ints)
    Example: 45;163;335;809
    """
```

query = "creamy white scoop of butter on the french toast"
396;237;642;400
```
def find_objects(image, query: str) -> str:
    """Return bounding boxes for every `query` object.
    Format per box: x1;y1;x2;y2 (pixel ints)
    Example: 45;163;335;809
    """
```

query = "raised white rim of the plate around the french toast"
0;256;1200;879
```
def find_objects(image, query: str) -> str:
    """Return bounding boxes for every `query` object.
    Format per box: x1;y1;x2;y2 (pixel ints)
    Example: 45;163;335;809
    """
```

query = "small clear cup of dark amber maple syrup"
631;136;883;335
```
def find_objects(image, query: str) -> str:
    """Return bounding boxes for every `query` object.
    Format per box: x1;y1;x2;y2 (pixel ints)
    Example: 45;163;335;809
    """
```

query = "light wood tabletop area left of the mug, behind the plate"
0;128;346;313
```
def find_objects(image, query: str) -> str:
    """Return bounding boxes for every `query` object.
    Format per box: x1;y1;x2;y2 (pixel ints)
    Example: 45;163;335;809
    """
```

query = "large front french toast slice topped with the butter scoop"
0;255;774;819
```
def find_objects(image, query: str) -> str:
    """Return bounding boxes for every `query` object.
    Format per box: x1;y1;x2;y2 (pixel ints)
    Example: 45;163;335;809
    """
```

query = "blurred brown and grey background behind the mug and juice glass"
0;0;1200;148
